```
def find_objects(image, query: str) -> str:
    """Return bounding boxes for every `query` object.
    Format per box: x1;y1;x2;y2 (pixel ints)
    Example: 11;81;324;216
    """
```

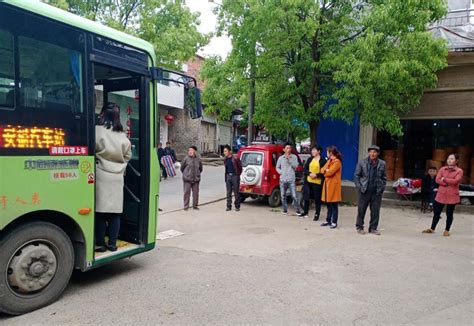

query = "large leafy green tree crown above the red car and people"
203;0;447;143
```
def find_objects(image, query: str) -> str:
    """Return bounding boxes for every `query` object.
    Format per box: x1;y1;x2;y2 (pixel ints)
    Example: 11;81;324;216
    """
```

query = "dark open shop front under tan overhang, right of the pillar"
376;25;474;184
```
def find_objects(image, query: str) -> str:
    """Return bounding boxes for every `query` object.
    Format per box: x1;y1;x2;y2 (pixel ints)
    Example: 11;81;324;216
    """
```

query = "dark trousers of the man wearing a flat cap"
356;189;382;231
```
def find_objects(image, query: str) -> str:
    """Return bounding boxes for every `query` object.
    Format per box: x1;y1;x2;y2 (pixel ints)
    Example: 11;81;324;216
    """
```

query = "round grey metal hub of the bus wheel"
8;244;57;293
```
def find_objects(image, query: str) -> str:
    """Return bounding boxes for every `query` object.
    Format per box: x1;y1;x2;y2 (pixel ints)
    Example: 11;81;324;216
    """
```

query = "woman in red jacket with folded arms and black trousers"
423;154;463;237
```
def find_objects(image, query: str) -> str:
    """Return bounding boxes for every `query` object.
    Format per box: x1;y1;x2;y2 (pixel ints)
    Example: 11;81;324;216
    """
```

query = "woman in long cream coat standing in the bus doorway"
95;103;132;252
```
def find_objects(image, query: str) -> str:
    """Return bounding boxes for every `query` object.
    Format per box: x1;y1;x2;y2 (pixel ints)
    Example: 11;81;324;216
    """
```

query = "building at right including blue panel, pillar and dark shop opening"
318;0;474;184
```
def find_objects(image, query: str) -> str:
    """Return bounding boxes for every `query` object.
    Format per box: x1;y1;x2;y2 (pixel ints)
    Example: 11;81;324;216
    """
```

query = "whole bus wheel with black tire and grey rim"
0;222;74;315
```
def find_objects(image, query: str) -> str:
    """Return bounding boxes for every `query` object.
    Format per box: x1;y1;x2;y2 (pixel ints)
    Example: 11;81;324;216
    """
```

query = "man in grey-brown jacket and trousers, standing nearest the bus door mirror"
181;146;202;211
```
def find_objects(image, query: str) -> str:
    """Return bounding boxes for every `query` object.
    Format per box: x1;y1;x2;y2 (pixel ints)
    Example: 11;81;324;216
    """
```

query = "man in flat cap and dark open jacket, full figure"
354;145;387;235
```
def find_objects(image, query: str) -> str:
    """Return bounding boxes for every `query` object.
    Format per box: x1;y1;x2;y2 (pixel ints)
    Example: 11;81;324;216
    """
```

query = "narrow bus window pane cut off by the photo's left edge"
0;29;15;108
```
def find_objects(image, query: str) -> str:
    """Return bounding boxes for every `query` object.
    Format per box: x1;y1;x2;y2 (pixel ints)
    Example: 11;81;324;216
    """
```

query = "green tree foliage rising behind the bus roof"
47;0;210;68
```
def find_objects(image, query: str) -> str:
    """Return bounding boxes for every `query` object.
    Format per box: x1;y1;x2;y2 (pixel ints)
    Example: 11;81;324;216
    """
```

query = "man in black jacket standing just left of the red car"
224;145;242;212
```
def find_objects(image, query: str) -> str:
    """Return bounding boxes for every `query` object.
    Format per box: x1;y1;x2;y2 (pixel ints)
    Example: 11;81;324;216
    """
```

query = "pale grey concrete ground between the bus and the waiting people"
0;201;474;326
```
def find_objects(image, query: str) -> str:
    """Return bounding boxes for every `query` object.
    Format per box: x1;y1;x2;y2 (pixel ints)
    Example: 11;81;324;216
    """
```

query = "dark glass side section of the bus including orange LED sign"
0;12;89;156
